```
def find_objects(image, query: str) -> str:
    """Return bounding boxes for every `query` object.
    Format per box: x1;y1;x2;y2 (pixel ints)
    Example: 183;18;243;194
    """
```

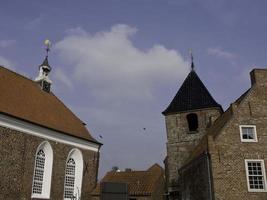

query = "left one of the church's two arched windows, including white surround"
32;141;53;198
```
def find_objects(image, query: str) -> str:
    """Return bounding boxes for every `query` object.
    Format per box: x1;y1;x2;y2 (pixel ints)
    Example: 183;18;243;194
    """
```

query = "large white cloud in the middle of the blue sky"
55;24;187;100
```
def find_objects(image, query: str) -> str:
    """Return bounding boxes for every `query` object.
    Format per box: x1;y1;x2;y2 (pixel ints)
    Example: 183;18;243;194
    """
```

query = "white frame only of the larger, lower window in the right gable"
245;159;267;192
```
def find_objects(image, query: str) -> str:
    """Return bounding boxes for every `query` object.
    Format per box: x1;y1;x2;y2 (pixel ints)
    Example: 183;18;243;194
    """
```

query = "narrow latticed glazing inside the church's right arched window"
64;158;75;198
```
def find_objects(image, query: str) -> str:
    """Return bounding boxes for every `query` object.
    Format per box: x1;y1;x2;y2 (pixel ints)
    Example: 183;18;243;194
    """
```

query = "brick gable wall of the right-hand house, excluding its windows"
209;84;267;200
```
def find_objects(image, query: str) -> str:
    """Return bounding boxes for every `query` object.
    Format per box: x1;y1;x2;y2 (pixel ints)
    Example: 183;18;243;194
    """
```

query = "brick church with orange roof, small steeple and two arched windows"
0;44;102;200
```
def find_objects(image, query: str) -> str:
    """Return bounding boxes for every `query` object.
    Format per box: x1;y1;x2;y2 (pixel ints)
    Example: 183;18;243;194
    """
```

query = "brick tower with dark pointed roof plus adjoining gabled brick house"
162;60;267;200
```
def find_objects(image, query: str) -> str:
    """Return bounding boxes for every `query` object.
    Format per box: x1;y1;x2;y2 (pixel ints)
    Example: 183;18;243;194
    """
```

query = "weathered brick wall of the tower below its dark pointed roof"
165;109;221;188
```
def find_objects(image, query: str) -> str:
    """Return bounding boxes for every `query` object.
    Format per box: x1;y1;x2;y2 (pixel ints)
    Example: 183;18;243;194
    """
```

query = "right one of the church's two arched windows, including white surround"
64;149;83;200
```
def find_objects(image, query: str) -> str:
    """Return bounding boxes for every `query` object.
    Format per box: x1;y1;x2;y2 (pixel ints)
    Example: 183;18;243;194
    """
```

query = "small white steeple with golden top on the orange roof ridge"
35;40;52;93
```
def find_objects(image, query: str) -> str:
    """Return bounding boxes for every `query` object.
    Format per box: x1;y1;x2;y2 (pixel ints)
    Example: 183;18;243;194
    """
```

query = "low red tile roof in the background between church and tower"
91;164;164;196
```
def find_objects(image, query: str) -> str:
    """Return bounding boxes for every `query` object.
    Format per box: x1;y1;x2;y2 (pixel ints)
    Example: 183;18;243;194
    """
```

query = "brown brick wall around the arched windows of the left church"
0;127;98;200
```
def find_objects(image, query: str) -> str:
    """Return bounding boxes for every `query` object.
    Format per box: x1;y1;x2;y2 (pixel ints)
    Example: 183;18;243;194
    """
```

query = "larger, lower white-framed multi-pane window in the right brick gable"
245;159;267;192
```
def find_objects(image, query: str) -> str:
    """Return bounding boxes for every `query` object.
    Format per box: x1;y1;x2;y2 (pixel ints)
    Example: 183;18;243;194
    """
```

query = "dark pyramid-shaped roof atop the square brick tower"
162;69;222;115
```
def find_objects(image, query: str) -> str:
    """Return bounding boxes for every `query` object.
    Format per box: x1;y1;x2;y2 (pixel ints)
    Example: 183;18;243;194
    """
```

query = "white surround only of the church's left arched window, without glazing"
31;141;53;199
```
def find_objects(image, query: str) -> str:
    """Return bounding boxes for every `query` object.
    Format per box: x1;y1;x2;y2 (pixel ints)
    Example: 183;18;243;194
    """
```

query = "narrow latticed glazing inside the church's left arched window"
32;149;45;194
